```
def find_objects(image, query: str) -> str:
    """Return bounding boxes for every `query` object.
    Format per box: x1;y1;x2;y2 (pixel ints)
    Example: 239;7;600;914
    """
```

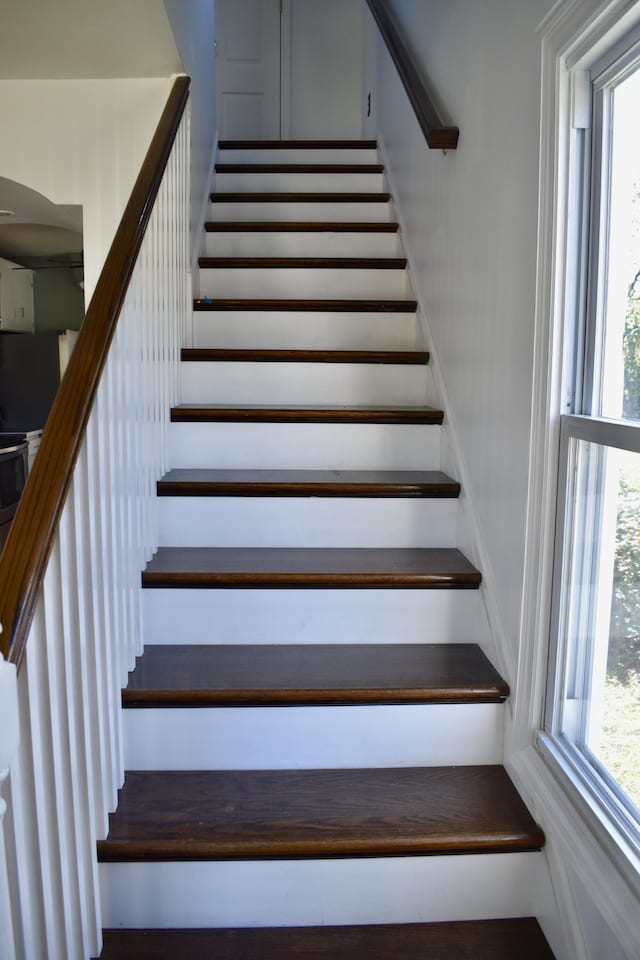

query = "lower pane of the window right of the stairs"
561;439;640;807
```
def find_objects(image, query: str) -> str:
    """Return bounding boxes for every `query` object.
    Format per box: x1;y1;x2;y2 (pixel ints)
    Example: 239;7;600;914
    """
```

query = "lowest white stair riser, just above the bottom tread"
100;853;545;928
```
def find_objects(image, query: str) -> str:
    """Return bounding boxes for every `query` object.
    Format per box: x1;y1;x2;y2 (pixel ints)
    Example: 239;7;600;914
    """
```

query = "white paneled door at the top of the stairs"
216;0;281;140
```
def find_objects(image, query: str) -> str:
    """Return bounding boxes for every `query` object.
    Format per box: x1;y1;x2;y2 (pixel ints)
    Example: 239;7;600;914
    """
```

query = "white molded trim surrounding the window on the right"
506;0;640;960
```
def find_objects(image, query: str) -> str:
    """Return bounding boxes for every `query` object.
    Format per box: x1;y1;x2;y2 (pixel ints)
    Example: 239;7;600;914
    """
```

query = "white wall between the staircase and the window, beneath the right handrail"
377;0;551;681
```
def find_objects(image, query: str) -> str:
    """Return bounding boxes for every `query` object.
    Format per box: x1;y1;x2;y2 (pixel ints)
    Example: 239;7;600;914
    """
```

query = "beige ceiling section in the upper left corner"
0;0;182;79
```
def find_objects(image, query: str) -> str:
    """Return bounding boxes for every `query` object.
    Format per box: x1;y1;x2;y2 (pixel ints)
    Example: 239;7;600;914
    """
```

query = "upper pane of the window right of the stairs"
601;69;640;420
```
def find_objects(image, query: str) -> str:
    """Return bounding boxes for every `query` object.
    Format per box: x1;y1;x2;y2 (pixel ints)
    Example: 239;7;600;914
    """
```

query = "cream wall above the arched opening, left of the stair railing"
0;79;171;304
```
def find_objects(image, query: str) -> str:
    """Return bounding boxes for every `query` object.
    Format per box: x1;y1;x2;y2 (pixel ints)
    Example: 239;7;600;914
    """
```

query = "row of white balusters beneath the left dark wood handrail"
0;101;191;960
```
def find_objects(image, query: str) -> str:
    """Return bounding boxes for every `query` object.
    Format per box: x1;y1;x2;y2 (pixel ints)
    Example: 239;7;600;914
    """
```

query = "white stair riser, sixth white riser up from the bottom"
181;360;428;406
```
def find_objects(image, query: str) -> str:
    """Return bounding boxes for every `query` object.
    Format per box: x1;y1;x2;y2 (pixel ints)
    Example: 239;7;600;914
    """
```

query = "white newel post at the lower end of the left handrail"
0;625;20;960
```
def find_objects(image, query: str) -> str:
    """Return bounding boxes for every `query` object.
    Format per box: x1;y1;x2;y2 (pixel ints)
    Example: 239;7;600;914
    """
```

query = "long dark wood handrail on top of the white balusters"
0;77;190;667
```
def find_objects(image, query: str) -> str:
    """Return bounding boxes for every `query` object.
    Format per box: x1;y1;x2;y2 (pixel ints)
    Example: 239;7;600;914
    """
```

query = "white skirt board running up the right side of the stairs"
378;131;517;688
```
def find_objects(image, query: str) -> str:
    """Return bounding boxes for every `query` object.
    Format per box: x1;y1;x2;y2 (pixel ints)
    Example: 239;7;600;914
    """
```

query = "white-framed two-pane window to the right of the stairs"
545;39;640;852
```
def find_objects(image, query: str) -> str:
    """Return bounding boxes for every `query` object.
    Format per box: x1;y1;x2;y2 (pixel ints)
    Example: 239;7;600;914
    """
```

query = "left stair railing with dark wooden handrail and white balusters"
0;77;191;960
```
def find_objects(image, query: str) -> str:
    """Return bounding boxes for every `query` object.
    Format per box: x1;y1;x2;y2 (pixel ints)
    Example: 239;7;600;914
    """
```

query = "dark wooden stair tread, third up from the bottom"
122;643;509;707
